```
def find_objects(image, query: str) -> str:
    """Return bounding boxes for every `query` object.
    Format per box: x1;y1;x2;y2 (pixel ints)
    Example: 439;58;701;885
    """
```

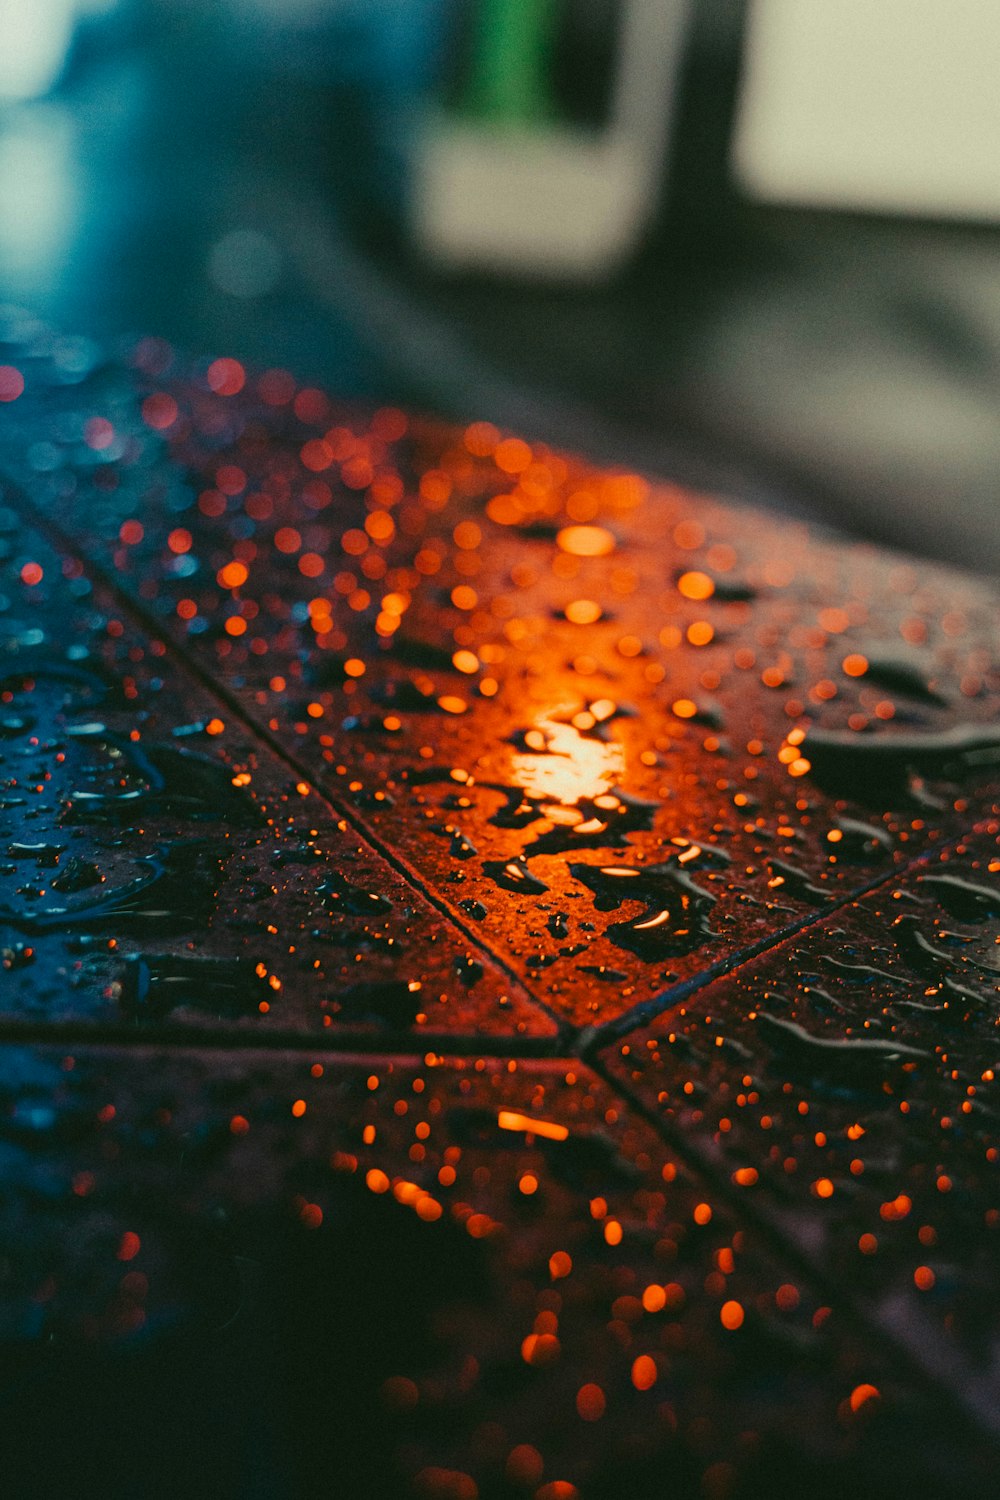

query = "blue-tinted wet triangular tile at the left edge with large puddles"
0;513;556;1047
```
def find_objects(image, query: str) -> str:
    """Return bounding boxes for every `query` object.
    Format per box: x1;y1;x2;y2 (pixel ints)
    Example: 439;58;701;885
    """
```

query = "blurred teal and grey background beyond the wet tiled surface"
0;0;1000;573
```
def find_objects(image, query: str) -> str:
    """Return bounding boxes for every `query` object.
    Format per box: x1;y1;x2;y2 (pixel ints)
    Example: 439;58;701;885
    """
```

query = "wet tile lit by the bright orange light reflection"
3;327;1000;1023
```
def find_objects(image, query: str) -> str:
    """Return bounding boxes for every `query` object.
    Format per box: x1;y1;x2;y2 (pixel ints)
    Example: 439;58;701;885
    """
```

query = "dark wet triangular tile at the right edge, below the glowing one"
603;821;1000;1421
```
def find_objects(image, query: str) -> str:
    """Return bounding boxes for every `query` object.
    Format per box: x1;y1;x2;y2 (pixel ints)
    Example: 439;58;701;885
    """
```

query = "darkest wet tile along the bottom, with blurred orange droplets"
0;1047;987;1500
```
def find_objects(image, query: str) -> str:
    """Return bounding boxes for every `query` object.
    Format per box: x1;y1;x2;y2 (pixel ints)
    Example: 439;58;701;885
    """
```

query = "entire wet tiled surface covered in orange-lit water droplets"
0;321;1000;1500
